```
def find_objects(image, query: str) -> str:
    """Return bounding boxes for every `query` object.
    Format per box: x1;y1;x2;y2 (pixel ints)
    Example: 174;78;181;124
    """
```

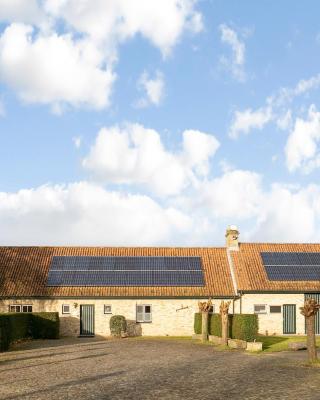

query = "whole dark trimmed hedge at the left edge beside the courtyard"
0;312;59;351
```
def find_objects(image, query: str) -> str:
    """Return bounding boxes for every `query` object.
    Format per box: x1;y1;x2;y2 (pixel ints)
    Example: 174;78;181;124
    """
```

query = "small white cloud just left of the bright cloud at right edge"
229;107;272;139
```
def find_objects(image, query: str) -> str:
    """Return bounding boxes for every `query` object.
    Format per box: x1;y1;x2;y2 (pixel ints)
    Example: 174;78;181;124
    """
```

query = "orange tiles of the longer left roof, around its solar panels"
0;247;234;297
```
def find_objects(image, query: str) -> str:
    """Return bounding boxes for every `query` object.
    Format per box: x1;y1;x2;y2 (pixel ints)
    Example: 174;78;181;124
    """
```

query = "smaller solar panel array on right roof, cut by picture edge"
260;252;320;281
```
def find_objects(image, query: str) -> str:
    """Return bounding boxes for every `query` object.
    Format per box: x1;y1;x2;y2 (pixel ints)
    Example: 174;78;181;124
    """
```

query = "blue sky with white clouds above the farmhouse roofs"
0;0;320;246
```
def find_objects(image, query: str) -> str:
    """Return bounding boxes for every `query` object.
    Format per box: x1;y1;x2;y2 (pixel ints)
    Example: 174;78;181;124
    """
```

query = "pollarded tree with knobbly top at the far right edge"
300;299;320;362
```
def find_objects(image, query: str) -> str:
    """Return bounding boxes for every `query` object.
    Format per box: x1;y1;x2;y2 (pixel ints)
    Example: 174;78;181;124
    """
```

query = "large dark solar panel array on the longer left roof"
47;256;204;286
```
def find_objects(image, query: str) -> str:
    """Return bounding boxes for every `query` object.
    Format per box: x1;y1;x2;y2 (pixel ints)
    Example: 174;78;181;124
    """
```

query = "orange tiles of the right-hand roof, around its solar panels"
231;243;320;292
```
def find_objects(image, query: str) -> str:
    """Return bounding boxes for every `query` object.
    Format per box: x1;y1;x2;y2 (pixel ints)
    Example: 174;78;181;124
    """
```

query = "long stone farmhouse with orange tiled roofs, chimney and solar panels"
0;226;320;336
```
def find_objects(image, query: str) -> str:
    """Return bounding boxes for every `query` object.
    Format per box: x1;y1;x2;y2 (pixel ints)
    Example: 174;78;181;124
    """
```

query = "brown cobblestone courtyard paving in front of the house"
0;339;320;400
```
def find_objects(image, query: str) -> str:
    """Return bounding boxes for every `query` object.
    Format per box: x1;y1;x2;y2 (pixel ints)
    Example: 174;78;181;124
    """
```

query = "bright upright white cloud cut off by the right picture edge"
285;105;320;173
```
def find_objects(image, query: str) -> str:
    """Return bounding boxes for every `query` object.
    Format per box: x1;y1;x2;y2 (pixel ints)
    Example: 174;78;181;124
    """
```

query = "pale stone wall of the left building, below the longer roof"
0;299;232;336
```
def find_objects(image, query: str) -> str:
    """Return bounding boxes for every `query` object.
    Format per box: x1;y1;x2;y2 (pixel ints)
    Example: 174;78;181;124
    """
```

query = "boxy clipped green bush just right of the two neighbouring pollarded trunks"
231;314;258;342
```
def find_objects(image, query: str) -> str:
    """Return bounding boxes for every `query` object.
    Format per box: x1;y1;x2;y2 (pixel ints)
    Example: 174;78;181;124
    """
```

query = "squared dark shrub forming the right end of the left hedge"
30;312;60;339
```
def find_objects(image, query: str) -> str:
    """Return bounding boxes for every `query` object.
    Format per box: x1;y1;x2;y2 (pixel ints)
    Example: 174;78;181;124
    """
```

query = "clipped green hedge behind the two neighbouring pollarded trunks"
194;313;258;341
